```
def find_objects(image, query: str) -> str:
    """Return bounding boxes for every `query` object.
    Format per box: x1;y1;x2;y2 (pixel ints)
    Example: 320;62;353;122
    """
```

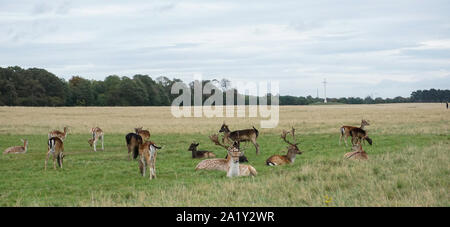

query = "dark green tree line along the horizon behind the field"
0;66;450;106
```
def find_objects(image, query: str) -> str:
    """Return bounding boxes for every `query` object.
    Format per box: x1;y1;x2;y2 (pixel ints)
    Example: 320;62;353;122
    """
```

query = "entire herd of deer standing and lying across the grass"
3;120;372;180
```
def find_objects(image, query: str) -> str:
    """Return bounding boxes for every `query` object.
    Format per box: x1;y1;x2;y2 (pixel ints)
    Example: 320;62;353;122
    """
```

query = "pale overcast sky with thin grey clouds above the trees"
0;0;450;97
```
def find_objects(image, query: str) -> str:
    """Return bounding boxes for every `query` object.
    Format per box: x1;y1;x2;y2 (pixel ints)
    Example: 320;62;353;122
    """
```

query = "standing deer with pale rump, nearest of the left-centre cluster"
138;141;161;180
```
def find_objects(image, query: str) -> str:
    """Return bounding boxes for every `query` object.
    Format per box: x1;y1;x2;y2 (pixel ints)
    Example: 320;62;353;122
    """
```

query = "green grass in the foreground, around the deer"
0;134;450;206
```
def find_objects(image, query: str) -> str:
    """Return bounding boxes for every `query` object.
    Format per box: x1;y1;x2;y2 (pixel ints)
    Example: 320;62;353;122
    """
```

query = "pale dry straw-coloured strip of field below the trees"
0;103;450;135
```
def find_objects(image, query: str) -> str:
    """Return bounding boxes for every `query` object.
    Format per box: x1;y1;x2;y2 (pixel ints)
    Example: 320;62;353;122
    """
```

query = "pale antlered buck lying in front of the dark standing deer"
195;134;258;177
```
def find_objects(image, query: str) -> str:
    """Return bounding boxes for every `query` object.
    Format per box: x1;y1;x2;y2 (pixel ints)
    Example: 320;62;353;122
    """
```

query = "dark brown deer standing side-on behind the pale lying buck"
219;122;259;155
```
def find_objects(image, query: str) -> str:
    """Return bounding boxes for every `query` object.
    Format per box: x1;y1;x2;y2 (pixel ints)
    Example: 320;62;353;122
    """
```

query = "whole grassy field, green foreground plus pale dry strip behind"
0;104;450;206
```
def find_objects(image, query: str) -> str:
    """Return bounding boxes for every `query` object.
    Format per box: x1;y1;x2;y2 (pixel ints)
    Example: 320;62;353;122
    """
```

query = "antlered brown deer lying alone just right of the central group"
266;128;302;166
